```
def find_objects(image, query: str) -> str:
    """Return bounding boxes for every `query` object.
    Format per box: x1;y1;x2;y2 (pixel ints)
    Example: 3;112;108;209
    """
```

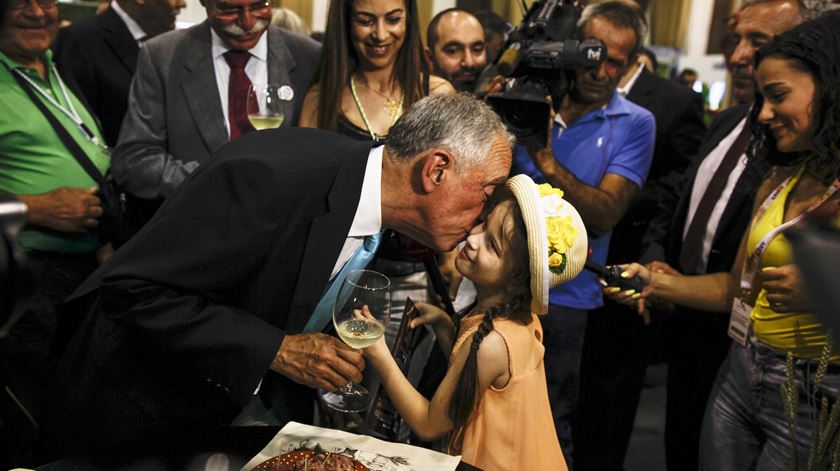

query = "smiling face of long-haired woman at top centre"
350;0;408;69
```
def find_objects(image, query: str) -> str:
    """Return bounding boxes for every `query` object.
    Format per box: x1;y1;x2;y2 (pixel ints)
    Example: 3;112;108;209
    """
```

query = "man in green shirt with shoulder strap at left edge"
0;0;110;469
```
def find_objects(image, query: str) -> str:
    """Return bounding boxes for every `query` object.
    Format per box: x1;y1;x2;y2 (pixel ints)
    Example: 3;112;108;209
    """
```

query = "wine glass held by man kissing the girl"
321;270;391;413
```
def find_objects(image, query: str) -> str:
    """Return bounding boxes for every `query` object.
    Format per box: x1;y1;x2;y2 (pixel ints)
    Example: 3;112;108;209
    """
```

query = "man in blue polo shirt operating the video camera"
511;1;655;468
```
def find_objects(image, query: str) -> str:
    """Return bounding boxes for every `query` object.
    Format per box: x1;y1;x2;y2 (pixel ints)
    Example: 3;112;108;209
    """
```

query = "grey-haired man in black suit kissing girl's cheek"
47;95;512;462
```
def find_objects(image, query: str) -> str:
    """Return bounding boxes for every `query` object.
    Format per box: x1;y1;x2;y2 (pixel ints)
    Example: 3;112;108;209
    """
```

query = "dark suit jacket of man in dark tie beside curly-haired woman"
643;101;767;273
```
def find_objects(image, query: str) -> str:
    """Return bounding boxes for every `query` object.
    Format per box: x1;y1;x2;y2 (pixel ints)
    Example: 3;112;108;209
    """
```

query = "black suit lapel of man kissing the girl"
285;143;370;334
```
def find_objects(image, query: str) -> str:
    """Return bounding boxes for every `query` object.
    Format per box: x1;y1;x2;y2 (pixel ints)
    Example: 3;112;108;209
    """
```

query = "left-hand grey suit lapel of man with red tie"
180;21;229;154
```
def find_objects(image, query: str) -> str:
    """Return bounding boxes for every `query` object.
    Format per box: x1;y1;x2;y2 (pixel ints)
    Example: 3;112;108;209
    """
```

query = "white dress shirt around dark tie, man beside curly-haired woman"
682;118;747;273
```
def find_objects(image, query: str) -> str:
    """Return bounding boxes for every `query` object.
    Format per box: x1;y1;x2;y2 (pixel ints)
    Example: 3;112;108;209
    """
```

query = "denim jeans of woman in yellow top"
700;340;840;471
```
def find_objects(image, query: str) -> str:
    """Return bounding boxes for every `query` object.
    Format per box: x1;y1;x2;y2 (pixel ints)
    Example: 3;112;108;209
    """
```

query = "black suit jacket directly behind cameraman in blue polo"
607;69;706;264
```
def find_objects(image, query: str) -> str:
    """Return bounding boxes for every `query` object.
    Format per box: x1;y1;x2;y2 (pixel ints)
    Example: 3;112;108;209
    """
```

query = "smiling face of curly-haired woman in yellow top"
755;57;816;152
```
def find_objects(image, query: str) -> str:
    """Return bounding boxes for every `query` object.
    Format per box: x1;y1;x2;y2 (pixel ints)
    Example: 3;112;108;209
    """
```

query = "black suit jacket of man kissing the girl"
47;128;371;452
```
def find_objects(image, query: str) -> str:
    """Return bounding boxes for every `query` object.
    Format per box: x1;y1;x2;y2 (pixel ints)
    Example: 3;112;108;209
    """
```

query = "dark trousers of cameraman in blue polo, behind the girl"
540;304;587;469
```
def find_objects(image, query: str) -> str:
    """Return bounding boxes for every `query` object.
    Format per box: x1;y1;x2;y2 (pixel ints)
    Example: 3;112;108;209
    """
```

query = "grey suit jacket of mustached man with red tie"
111;21;320;199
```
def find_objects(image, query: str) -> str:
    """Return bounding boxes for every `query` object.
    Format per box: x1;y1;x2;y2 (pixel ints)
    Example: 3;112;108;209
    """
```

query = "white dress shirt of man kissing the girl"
330;146;385;279
